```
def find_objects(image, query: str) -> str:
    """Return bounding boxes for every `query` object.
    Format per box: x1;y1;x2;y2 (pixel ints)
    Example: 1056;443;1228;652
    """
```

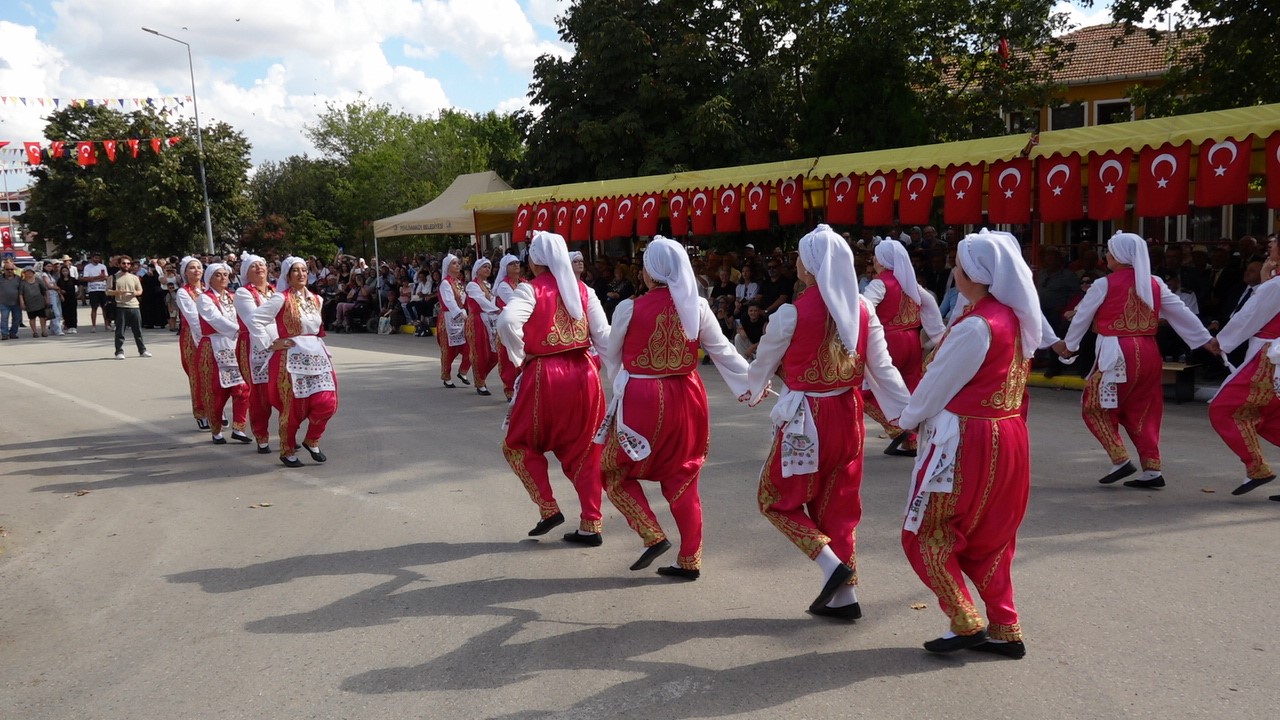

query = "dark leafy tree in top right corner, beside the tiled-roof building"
1111;0;1280;117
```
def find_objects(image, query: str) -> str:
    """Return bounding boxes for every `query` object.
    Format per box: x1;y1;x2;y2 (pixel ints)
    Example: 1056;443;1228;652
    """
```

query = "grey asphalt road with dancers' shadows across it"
0;313;1280;720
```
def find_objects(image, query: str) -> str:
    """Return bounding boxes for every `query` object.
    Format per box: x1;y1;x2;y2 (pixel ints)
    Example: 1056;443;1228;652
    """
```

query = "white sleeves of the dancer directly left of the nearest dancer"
748;293;911;420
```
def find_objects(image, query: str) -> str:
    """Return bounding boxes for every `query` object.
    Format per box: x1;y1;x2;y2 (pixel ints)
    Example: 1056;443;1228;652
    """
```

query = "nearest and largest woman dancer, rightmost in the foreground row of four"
899;229;1042;657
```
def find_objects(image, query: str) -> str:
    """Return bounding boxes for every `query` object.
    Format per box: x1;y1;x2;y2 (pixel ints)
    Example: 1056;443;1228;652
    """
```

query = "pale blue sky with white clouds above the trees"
0;0;1110;184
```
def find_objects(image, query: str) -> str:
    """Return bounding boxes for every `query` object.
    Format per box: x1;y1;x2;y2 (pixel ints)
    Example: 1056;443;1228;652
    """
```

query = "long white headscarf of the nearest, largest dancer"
956;232;1043;357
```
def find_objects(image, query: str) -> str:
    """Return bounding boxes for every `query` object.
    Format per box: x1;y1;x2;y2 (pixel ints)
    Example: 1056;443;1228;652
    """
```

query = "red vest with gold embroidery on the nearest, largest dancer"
940;296;1030;419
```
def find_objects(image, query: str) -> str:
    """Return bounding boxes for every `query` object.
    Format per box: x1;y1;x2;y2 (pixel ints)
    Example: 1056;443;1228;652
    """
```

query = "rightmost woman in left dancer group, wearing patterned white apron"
251;256;338;468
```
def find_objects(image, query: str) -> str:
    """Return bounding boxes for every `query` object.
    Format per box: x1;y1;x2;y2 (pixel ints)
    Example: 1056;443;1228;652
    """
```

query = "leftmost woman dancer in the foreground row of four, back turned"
498;232;609;547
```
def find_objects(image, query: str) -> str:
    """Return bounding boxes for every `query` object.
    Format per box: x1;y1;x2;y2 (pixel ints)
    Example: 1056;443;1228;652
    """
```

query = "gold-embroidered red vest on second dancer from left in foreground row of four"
622;287;698;375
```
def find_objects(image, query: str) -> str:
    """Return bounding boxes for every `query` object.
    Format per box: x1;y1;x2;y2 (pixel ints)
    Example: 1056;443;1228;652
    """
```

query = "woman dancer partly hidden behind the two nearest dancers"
863;241;946;457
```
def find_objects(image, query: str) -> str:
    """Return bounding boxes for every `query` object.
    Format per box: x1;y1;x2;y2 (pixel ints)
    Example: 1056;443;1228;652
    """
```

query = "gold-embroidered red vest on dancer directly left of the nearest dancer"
781;284;870;392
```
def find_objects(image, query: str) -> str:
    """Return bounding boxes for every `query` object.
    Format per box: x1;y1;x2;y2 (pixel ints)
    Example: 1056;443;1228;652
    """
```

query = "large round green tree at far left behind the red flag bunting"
20;106;252;256
